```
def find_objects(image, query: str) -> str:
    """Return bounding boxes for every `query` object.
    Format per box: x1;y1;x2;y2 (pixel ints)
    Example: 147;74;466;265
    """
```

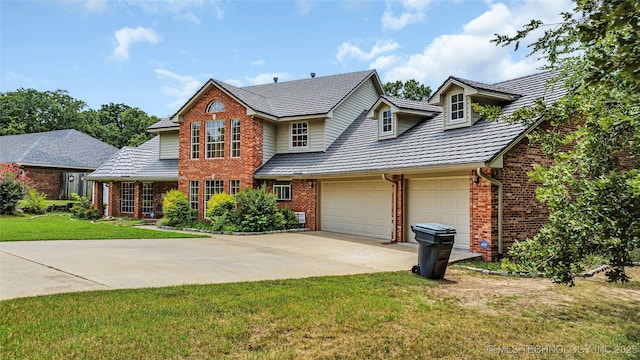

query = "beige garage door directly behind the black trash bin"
407;176;469;250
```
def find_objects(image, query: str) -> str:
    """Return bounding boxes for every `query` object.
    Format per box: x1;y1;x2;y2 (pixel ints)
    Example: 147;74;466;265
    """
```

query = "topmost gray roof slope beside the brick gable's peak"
199;70;377;118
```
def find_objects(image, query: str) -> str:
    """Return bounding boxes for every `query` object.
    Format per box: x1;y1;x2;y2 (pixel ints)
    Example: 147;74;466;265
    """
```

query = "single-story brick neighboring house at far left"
0;129;118;200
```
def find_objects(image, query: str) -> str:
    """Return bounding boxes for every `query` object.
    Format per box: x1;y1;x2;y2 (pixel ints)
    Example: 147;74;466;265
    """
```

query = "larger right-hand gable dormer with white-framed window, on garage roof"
429;76;520;130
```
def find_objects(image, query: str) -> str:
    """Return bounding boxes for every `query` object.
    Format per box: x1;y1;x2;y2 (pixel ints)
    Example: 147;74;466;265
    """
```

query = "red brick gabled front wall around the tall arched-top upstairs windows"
178;87;263;218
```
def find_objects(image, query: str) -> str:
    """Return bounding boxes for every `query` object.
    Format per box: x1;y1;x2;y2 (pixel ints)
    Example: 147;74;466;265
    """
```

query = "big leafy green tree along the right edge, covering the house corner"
488;0;640;285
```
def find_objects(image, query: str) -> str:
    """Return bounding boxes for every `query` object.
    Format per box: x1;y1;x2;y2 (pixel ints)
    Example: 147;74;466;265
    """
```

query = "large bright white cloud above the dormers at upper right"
380;0;572;86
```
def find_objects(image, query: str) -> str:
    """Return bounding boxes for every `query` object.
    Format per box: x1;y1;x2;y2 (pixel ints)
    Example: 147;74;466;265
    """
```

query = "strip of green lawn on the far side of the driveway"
0;214;205;241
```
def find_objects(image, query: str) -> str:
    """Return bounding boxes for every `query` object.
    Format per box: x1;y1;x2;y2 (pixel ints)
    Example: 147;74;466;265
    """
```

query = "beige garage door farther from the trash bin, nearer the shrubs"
320;180;392;240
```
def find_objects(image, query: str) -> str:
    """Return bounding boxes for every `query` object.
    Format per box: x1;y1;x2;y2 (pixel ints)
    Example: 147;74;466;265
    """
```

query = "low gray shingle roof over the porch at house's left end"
87;136;178;181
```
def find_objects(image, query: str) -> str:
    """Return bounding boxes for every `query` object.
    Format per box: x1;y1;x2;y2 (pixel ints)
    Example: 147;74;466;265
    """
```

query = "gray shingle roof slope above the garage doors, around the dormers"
256;72;564;177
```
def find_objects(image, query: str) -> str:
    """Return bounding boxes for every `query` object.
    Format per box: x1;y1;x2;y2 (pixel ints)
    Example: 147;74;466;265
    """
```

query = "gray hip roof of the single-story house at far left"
0;129;118;170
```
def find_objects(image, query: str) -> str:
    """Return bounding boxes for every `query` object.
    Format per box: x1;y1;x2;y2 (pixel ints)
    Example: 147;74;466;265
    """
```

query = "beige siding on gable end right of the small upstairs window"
321;79;380;151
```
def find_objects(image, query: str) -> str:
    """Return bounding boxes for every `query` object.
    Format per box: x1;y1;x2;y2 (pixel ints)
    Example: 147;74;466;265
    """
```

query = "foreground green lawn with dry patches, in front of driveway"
0;269;640;359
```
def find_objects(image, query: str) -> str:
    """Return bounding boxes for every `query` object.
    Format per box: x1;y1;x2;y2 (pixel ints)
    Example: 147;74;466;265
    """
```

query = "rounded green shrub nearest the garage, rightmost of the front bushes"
233;186;284;232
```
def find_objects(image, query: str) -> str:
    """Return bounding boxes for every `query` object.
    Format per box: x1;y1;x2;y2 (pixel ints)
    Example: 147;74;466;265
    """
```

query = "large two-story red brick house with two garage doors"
91;70;564;260
